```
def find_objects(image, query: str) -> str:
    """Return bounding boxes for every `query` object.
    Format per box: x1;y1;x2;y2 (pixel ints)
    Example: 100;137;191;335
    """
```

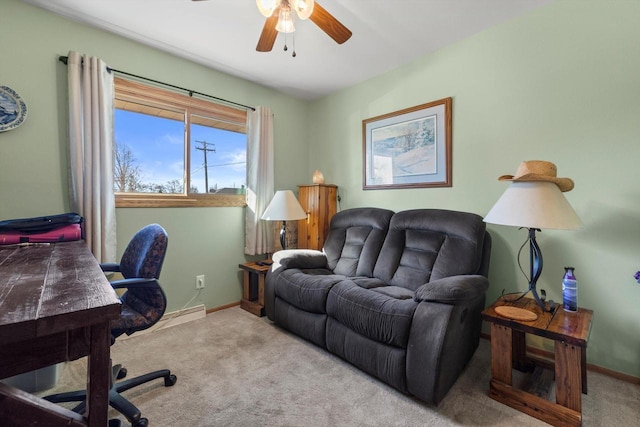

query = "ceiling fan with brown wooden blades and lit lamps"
193;0;352;52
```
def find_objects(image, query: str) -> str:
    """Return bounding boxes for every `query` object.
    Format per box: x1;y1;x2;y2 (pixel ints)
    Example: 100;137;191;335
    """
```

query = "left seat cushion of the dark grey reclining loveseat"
274;268;344;313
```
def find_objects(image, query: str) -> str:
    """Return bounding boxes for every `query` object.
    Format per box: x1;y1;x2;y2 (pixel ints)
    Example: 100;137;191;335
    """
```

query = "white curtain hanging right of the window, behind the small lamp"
244;107;274;255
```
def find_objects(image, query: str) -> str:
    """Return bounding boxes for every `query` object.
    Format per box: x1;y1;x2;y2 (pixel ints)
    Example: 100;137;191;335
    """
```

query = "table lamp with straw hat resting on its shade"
484;160;581;312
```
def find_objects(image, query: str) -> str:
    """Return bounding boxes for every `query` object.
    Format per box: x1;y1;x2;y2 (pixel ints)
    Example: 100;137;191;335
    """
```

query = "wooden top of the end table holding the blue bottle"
482;298;593;347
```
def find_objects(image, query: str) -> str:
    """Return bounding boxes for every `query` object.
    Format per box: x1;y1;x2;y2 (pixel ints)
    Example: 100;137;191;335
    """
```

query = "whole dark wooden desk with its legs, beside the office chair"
0;241;120;427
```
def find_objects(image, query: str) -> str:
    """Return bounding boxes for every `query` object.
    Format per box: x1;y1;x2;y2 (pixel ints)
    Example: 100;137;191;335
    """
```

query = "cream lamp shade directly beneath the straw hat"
484;181;582;230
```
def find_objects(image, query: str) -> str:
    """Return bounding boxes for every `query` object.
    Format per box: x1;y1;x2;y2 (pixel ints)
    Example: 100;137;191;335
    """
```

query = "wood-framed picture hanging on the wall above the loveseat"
362;98;452;190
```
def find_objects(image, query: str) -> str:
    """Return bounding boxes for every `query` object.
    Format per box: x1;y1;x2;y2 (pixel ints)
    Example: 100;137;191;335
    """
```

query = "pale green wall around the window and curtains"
0;0;309;318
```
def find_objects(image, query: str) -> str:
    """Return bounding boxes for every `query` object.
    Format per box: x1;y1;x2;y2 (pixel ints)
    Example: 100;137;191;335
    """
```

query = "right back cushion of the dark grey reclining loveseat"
373;209;486;290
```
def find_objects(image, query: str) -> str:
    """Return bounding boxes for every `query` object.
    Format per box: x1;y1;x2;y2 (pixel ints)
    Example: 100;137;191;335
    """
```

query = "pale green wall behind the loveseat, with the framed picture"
309;0;640;376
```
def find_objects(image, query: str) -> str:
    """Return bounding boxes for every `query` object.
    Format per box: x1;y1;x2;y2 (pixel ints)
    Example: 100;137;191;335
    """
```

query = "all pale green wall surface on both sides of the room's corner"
0;0;640;377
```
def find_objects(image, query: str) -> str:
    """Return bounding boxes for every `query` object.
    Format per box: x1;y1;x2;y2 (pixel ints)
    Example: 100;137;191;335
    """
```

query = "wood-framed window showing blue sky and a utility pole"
114;78;247;207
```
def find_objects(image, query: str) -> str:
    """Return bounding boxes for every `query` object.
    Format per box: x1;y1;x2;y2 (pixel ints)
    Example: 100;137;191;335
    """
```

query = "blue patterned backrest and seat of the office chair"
111;224;168;337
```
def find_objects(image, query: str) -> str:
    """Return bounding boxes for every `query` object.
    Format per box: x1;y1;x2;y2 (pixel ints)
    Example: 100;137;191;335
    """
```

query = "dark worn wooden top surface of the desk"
0;241;120;345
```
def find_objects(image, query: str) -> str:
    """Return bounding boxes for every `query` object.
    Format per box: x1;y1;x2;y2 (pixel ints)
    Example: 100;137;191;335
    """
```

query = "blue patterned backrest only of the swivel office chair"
120;224;168;279
